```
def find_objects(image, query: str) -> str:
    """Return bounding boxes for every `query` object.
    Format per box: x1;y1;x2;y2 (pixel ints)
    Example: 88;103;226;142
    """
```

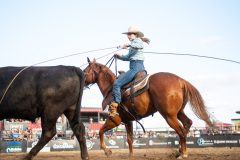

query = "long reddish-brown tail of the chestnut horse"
184;81;213;126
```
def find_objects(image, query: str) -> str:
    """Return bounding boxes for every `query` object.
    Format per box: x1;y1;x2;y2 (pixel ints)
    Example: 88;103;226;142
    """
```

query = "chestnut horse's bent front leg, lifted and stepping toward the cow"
99;115;122;156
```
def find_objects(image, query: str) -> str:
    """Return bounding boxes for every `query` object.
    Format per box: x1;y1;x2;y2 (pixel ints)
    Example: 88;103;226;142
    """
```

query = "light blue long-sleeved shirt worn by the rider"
119;38;145;61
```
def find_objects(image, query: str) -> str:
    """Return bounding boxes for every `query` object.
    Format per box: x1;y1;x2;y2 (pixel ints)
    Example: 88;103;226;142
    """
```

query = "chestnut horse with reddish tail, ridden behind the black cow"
84;59;212;158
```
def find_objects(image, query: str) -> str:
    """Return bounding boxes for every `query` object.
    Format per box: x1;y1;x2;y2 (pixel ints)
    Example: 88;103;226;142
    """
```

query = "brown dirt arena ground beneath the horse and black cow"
0;147;240;160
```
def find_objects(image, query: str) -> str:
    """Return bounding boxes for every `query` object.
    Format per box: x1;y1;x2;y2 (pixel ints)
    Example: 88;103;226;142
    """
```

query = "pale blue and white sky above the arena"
0;0;240;127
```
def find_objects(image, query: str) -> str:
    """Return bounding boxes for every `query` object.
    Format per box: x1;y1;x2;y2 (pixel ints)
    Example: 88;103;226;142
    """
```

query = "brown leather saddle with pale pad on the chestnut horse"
119;70;150;101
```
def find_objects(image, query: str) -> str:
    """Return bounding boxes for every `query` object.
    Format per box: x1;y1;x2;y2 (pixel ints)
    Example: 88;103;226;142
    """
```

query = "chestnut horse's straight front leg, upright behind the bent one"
125;122;133;158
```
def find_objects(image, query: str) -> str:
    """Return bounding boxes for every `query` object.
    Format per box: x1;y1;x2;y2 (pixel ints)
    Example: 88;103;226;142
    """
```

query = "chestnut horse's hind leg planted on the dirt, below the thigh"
165;116;188;158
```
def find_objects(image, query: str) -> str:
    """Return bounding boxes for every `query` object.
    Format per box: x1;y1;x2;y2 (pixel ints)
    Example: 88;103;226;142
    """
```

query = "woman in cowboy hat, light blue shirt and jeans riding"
109;26;150;117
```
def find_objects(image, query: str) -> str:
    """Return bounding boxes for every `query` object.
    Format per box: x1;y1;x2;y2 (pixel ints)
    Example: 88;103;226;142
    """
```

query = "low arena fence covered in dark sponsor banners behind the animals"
0;134;240;153
